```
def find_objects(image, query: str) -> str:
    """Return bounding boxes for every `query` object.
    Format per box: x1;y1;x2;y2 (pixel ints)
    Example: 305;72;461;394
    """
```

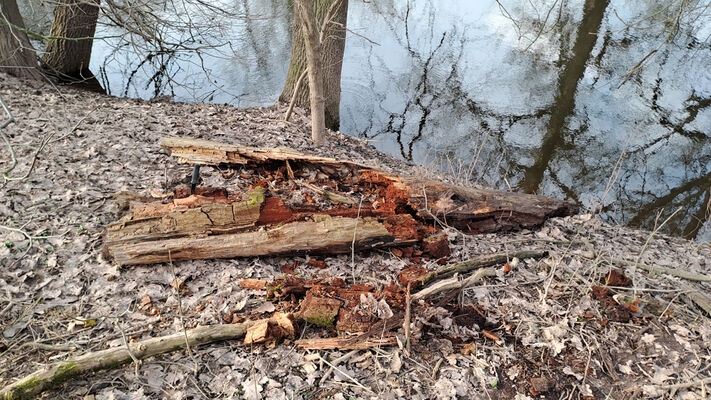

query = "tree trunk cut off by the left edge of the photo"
0;0;42;79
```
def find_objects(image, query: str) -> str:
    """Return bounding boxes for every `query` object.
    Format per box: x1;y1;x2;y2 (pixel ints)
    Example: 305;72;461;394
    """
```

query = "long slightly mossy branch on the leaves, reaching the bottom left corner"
0;321;257;400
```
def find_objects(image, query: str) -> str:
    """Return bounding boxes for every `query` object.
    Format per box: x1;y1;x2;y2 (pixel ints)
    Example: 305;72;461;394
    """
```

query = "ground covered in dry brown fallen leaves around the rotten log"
0;74;711;400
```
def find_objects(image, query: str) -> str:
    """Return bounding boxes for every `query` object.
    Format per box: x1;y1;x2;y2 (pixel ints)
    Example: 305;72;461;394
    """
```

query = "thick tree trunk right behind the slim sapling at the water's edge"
279;0;348;130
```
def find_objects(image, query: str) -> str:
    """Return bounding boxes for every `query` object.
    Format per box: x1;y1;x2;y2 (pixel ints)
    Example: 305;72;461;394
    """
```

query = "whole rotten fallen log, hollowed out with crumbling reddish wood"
104;138;577;265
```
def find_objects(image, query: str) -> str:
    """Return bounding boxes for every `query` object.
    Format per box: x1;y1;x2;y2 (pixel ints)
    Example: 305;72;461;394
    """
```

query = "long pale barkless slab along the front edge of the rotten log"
106;215;417;266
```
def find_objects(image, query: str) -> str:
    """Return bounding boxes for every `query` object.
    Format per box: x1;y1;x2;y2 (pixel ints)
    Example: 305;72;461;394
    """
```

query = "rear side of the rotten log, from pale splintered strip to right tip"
160;138;578;233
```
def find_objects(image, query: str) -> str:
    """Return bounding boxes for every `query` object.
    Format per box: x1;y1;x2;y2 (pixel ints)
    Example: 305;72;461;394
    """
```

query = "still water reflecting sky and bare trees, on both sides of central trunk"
82;0;711;240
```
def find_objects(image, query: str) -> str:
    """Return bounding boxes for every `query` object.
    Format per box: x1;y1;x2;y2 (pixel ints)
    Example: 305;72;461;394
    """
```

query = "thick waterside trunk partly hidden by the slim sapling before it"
279;0;348;130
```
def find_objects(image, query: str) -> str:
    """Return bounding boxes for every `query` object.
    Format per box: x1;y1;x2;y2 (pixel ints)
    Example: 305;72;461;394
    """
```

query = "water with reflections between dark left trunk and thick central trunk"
95;0;290;104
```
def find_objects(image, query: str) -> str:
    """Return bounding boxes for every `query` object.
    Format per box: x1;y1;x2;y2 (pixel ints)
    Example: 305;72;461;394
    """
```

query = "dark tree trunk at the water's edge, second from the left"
42;0;99;83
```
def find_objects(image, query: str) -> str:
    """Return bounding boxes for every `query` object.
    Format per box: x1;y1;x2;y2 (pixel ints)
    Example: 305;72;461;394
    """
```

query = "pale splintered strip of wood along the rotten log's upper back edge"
160;137;370;169
